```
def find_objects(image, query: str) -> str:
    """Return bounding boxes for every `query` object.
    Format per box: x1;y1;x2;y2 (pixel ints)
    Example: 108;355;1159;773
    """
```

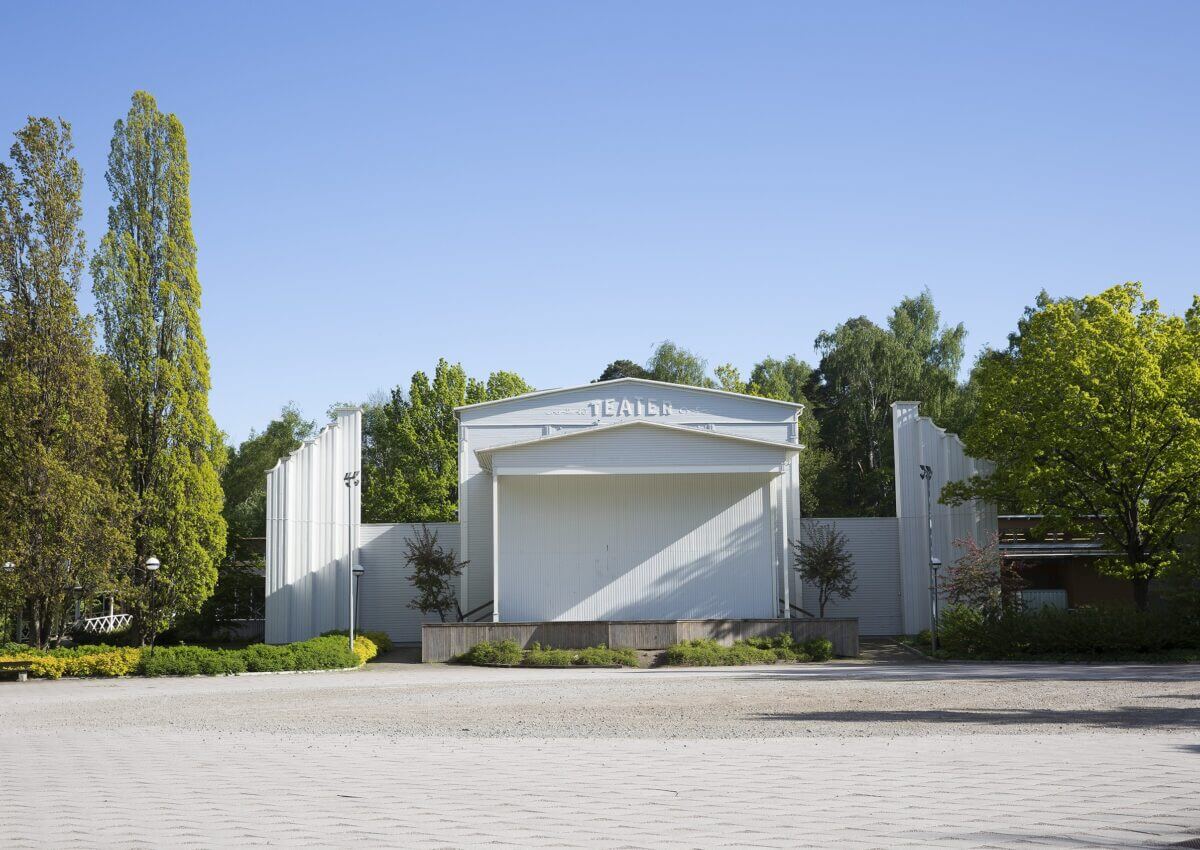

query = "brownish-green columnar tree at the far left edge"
0;118;130;646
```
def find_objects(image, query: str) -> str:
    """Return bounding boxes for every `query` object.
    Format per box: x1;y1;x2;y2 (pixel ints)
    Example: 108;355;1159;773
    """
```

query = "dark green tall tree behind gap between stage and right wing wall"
810;292;966;516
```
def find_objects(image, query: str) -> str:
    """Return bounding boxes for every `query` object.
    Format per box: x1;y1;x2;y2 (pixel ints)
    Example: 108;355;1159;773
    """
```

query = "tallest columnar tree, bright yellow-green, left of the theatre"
92;91;226;641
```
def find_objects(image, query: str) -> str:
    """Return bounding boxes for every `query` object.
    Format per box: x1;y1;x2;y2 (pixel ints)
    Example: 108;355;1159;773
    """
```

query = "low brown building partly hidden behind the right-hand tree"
997;514;1133;607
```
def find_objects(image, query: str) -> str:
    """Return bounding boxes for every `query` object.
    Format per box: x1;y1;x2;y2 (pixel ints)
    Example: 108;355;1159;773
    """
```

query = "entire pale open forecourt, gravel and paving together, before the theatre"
0;662;1200;849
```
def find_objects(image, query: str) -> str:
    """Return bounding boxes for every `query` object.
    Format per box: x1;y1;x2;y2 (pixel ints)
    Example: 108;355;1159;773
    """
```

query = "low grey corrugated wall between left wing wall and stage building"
358;522;458;644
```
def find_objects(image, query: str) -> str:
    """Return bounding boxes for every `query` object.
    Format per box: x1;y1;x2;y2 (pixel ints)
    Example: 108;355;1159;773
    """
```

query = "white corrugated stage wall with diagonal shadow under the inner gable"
497;474;778;622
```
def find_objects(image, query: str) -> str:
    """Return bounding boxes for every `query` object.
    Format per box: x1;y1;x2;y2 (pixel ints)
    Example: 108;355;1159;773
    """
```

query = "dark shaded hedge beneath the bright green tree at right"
938;605;1200;659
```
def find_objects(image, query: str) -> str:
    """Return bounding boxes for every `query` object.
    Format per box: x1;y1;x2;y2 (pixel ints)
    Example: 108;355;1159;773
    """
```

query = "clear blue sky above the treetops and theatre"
0;0;1200;439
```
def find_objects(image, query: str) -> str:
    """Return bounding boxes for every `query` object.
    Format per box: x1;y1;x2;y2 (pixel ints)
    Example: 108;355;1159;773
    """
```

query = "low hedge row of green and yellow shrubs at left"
0;635;379;678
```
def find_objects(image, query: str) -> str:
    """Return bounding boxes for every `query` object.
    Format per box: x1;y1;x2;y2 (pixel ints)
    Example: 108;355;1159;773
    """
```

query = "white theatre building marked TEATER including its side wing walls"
266;378;995;642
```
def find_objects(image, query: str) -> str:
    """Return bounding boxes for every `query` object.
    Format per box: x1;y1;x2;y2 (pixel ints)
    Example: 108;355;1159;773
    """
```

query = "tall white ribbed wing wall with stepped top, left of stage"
265;407;362;644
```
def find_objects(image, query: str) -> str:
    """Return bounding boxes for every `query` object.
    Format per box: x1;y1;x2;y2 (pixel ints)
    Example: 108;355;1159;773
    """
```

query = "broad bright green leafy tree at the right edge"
942;283;1200;609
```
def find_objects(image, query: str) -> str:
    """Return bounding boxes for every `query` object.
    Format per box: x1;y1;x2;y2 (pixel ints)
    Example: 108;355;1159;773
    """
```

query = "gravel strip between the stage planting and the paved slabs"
0;663;1200;738
